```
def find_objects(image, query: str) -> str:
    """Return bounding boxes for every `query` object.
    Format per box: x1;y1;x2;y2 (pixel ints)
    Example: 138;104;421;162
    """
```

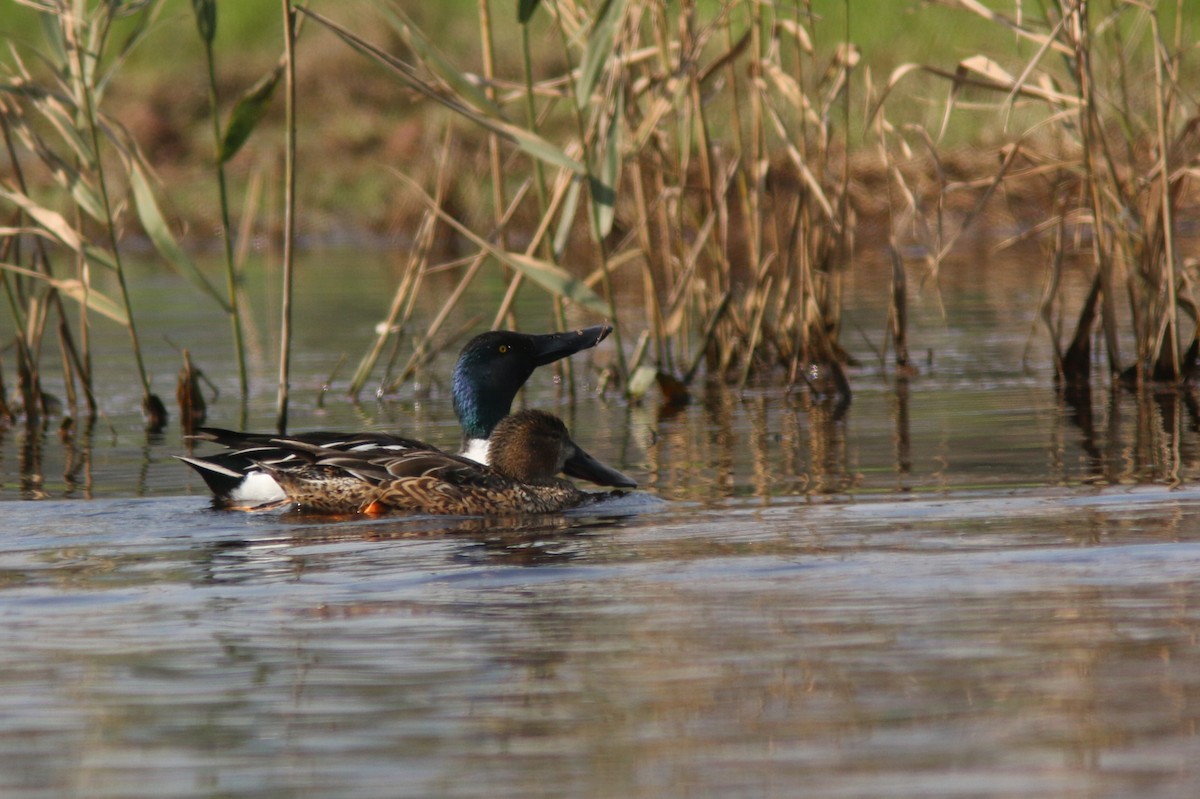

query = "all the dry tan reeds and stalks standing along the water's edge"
0;0;1200;429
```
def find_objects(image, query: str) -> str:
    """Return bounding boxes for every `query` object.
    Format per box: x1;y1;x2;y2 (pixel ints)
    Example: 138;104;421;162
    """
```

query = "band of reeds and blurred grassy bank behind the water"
0;0;1200;436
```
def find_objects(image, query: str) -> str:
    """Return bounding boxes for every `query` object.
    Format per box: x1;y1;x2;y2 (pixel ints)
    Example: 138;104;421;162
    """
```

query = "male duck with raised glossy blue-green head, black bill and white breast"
180;325;618;507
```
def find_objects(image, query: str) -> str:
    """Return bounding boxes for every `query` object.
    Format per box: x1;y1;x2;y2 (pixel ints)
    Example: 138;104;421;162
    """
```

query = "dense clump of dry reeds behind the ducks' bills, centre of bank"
310;0;857;395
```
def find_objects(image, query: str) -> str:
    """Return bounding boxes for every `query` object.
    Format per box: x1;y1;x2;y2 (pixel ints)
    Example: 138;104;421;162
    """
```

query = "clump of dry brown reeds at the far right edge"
870;0;1200;384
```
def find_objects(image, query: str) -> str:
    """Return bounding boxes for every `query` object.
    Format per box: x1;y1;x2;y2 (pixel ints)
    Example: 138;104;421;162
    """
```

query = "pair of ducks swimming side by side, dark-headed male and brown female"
180;325;637;516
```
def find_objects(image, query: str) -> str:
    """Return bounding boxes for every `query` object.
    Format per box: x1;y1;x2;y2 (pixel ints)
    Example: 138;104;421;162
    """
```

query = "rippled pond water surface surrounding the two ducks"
0;247;1200;799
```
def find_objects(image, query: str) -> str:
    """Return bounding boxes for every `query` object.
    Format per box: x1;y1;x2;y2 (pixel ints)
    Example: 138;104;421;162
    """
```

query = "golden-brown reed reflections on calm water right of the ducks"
623;378;1200;501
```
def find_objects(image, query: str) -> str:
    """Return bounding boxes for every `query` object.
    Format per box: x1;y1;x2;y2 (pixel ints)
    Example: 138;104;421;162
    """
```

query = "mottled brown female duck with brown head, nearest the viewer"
234;410;636;516
